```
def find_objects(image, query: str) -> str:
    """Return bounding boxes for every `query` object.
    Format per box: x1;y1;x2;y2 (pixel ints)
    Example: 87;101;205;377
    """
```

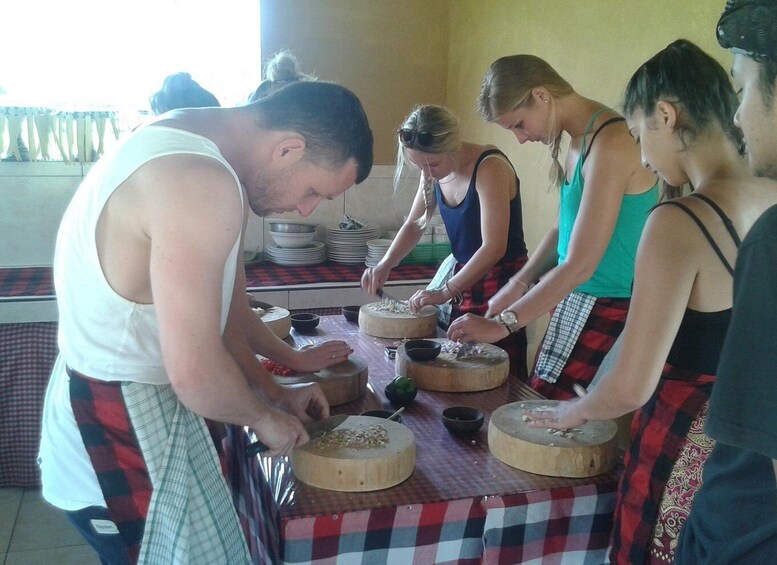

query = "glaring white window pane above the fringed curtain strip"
0;0;261;110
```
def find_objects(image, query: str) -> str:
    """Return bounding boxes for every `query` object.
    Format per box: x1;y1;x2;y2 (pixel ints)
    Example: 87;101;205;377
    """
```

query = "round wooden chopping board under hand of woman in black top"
488;400;618;478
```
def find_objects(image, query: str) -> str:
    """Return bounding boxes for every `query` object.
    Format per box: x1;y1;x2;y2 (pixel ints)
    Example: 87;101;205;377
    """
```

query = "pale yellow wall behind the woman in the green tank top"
447;0;731;251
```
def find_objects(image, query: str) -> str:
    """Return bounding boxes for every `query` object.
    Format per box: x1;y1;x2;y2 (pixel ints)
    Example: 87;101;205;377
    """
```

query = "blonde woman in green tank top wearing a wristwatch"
448;51;658;399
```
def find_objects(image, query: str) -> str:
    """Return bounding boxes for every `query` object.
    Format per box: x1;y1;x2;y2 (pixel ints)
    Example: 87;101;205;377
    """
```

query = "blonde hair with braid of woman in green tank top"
477;55;575;187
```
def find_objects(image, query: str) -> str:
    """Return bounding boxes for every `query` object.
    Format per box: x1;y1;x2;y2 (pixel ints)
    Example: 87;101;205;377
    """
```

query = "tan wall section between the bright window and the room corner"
260;0;449;164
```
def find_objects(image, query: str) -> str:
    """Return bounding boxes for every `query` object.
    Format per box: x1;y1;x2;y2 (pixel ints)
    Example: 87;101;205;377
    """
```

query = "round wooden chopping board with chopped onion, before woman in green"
395;339;510;392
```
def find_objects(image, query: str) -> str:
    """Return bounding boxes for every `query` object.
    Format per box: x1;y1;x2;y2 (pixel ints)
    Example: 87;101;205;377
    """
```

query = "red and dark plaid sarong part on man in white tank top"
68;369;152;563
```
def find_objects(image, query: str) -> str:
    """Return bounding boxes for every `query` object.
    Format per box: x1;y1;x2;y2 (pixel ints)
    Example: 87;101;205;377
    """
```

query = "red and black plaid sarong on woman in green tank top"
531;298;631;400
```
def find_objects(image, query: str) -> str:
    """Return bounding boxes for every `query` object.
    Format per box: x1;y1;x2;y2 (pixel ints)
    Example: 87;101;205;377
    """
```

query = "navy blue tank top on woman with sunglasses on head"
434;149;526;265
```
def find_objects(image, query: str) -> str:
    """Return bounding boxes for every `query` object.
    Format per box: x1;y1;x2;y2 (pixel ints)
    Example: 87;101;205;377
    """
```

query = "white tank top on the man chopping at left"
54;126;243;384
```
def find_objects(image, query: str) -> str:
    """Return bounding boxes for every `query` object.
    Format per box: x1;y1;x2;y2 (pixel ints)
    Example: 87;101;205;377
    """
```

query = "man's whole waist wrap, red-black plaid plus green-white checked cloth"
68;370;251;565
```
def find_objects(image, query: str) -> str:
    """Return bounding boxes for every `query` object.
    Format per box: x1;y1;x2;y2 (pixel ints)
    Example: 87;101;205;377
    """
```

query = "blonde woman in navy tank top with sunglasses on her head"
362;105;527;380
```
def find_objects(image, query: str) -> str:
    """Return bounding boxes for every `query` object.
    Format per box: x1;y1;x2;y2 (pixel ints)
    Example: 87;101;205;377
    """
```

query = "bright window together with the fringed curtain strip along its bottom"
0;0;261;162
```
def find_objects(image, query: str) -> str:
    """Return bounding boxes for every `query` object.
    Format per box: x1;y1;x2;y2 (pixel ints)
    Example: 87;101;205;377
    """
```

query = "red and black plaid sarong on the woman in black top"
610;363;715;565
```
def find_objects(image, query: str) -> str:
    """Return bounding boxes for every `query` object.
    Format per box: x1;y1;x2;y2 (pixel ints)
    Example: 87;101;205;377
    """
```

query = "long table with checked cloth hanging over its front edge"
227;316;620;564
